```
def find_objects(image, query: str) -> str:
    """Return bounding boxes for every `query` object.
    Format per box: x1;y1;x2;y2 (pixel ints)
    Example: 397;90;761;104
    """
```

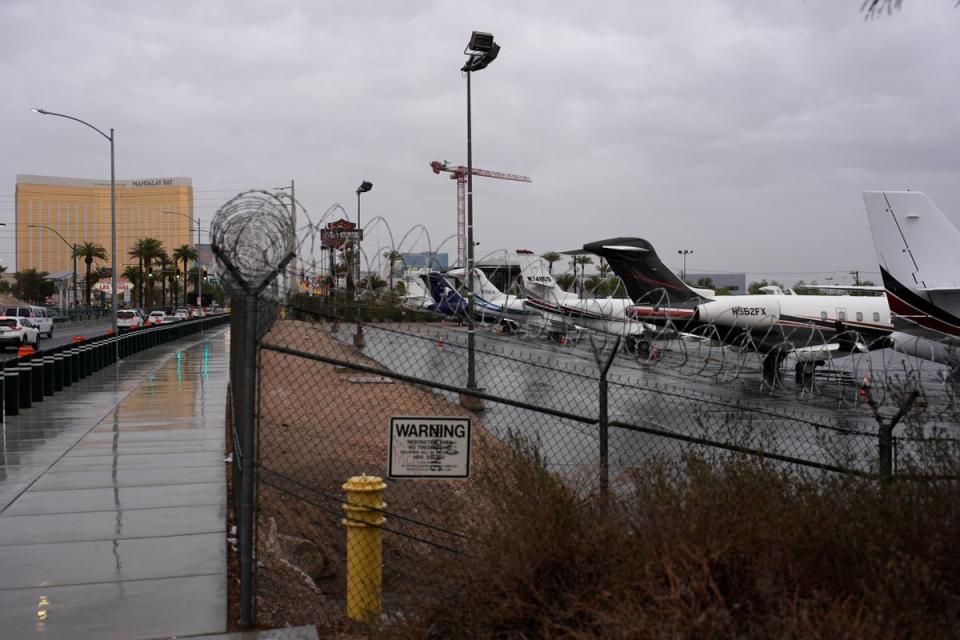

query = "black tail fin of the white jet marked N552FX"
583;238;710;306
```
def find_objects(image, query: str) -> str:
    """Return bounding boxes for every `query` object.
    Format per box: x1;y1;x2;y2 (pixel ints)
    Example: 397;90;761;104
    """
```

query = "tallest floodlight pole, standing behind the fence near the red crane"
460;31;500;400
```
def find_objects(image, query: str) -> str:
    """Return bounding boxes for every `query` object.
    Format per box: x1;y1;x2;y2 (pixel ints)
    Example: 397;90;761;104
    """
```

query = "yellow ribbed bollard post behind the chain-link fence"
343;475;387;624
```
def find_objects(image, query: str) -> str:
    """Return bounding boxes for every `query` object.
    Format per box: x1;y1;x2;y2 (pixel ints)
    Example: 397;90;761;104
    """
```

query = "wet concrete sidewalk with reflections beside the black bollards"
0;329;229;639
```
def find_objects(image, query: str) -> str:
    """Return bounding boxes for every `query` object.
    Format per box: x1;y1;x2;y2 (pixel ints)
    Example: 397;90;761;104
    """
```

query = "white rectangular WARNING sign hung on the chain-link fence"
387;416;470;478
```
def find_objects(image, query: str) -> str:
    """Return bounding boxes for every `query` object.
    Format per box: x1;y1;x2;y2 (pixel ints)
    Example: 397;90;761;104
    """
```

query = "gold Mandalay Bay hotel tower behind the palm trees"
16;175;196;298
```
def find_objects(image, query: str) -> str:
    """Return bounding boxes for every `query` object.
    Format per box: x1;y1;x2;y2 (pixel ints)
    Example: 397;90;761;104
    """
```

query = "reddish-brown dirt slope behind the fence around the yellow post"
228;320;505;637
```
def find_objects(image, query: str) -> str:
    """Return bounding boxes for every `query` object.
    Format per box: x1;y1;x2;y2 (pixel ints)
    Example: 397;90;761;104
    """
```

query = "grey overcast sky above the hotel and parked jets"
0;0;960;284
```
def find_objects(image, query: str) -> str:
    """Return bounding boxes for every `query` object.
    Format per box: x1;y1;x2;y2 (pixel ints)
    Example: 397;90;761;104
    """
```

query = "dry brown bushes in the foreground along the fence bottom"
381;447;960;638
